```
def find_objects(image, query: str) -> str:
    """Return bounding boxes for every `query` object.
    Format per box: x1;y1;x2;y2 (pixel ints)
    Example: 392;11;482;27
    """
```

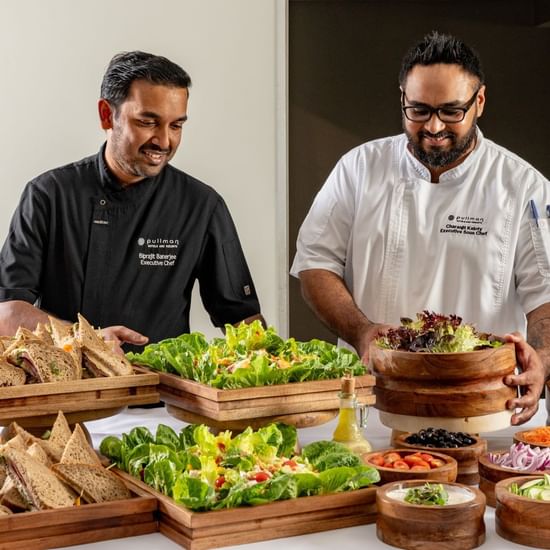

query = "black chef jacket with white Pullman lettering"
0;146;260;350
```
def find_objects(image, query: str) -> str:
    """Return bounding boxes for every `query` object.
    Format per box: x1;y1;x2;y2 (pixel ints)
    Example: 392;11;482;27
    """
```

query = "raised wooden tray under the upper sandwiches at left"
0;369;160;427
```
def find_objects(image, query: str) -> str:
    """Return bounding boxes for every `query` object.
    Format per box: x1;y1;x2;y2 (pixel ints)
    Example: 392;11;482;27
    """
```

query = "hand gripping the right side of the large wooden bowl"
504;332;545;426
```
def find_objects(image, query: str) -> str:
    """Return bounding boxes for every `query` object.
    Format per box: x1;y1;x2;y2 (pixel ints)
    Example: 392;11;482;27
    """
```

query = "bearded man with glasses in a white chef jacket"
291;31;550;424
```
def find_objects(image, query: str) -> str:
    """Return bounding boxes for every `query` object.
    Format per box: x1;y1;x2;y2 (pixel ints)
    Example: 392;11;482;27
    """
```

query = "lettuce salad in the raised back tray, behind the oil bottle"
127;321;366;389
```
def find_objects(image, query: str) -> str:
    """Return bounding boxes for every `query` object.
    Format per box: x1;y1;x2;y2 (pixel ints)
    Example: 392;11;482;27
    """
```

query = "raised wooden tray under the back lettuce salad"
136;367;375;421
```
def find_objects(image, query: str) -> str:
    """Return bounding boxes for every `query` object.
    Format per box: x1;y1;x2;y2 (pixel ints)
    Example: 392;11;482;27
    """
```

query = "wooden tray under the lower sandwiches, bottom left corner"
0;476;158;550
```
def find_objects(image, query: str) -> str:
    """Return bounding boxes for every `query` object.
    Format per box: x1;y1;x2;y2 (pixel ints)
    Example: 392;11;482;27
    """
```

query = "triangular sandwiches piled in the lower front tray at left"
0;412;131;515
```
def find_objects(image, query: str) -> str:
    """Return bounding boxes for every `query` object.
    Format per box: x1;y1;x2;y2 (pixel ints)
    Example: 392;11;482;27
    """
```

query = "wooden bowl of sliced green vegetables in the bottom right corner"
495;475;550;548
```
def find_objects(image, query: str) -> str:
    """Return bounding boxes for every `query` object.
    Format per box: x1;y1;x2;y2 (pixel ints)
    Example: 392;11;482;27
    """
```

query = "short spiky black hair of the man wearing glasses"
399;31;485;88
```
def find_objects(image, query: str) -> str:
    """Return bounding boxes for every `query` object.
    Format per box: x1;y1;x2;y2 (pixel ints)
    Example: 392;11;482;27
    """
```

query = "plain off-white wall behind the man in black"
0;0;287;336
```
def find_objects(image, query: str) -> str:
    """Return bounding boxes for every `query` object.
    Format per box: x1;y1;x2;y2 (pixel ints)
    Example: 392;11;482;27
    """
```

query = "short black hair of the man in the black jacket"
101;51;191;109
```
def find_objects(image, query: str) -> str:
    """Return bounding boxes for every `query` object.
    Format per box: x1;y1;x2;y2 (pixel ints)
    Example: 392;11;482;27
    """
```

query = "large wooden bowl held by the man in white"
369;342;516;433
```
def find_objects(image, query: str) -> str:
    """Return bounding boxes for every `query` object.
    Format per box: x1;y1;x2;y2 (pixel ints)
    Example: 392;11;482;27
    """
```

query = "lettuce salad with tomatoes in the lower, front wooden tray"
100;423;380;511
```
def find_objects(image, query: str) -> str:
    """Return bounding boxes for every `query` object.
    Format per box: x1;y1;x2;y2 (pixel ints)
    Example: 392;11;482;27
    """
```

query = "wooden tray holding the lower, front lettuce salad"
116;470;376;550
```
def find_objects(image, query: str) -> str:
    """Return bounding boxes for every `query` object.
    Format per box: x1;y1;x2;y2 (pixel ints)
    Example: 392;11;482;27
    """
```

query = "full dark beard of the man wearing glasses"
403;119;477;168
